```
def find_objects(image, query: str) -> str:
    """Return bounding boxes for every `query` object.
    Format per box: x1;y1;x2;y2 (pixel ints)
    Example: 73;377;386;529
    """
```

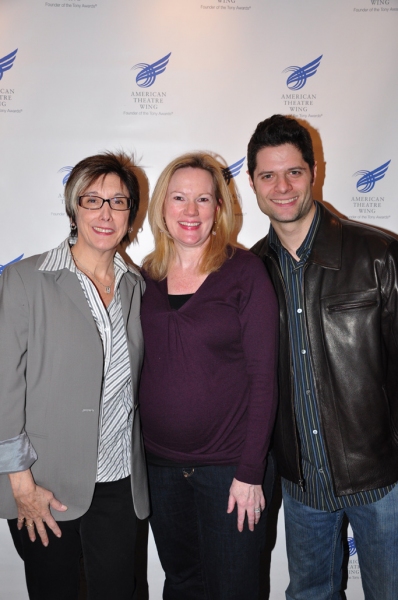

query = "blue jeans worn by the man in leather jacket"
282;485;398;600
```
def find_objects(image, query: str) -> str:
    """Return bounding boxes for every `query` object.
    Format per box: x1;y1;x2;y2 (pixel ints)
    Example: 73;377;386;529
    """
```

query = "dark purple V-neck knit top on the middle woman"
140;249;278;484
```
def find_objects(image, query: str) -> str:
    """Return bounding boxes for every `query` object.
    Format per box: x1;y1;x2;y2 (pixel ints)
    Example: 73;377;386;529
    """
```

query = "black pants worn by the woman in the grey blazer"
8;477;137;600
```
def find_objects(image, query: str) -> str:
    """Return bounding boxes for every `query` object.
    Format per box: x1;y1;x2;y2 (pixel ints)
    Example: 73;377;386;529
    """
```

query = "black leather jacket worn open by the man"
252;205;398;496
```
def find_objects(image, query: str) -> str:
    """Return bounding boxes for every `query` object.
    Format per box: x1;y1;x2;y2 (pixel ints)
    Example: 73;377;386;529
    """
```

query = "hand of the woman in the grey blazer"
9;469;67;546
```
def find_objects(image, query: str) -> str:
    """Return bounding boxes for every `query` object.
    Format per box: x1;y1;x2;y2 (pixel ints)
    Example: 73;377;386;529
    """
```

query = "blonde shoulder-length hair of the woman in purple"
143;152;235;281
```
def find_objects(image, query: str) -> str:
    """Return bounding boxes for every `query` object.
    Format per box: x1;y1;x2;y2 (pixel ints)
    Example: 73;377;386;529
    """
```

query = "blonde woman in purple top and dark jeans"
140;153;278;600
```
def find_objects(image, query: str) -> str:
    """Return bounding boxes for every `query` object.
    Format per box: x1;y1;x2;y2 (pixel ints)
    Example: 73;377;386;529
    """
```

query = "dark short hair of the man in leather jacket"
247;115;315;179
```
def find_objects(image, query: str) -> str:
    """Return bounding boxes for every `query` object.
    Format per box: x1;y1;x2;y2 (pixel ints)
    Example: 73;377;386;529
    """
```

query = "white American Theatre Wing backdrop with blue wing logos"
0;0;398;600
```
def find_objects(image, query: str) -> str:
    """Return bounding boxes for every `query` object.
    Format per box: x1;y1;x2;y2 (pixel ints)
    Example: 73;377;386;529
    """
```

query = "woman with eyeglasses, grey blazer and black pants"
0;153;149;600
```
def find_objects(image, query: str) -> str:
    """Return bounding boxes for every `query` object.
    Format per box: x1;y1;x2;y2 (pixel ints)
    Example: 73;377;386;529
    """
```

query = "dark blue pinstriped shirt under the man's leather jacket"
269;206;394;512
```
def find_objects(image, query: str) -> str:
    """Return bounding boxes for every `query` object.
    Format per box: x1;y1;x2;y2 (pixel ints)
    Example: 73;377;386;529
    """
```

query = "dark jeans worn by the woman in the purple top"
149;459;274;600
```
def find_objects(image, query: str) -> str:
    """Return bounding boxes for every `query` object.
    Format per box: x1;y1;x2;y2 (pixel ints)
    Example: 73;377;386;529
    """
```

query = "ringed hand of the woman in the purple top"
227;478;265;531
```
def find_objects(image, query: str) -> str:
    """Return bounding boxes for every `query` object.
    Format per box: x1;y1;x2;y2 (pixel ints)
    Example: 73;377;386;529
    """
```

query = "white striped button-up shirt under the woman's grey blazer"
40;240;133;482
